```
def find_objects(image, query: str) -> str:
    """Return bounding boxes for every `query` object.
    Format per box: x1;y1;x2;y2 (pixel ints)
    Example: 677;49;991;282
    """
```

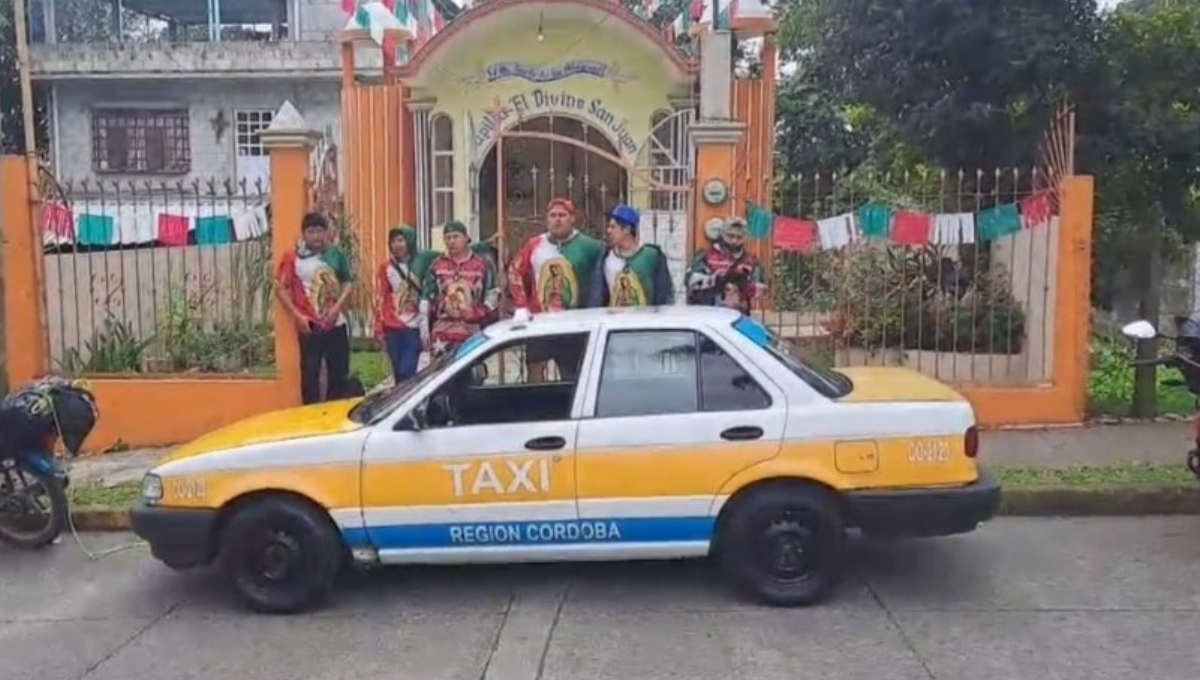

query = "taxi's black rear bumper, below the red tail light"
846;468;1001;538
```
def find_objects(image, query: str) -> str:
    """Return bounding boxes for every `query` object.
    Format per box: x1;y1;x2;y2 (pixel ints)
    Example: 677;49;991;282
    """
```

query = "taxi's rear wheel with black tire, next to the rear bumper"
718;483;846;607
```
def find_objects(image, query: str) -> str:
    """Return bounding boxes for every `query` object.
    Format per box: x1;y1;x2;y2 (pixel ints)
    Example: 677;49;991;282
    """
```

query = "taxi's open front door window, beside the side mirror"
430;332;588;427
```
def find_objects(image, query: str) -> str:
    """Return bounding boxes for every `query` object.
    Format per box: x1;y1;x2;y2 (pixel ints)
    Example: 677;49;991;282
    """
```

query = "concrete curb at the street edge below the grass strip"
71;486;1200;531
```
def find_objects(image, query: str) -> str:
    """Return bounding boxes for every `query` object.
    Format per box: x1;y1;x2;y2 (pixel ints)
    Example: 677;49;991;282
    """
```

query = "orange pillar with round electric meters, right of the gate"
688;120;746;253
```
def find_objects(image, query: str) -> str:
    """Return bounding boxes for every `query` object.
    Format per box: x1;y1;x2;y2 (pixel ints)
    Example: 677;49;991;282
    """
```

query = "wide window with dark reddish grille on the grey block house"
91;108;192;174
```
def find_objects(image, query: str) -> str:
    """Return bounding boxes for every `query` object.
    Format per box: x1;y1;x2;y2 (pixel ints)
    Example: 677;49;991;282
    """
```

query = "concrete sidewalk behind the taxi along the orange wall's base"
71;422;1192;486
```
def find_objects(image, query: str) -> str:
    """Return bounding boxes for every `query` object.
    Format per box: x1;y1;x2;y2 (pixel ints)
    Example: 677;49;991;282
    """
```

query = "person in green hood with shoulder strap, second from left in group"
374;224;436;383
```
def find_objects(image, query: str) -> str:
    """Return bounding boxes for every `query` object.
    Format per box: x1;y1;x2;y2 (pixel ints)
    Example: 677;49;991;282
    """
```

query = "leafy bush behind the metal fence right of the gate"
774;245;1026;354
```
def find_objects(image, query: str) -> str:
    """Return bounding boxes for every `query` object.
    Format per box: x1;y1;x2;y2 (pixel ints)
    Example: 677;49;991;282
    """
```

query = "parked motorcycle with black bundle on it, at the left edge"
0;377;100;549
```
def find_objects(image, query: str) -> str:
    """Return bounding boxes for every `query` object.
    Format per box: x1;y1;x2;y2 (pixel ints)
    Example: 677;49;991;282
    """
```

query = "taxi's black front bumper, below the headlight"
130;501;217;570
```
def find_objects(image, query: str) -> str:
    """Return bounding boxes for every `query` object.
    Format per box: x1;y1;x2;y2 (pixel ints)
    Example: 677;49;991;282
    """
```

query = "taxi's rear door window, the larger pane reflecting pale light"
595;330;700;417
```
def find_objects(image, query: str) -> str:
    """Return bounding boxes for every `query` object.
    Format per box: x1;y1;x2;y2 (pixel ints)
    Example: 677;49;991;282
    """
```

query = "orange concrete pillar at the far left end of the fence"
0;156;49;387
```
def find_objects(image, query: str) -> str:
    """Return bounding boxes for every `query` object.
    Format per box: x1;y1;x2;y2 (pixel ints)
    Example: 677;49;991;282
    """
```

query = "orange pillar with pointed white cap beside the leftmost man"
259;102;318;405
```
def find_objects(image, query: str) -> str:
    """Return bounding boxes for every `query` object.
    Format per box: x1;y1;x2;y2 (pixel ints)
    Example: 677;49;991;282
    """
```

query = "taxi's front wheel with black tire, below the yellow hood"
221;495;346;614
